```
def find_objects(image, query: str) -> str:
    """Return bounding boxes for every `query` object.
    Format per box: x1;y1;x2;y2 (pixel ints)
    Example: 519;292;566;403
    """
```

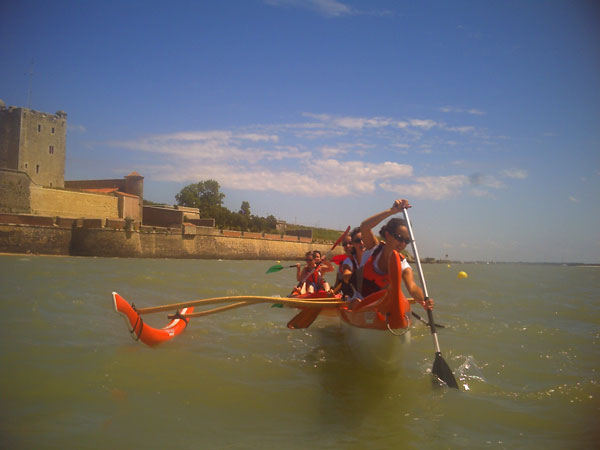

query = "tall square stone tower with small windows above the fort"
0;100;67;187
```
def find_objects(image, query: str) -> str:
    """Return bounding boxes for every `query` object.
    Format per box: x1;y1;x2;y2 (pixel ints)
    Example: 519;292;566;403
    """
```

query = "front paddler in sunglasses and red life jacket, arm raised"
357;199;433;310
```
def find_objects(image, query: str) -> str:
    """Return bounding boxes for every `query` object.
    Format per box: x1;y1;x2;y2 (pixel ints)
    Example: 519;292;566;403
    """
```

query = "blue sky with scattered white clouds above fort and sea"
0;0;600;263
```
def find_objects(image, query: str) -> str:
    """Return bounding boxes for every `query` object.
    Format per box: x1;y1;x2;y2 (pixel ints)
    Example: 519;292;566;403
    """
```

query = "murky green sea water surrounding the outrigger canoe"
0;256;600;449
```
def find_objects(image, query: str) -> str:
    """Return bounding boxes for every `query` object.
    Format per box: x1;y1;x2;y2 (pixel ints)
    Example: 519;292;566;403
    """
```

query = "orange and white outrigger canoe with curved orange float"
113;252;411;366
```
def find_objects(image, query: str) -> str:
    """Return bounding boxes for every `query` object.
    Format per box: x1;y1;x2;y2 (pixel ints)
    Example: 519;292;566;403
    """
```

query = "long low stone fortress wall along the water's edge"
0;214;328;260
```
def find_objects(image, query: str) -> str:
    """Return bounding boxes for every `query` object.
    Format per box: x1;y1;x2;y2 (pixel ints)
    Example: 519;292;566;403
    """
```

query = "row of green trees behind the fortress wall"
175;180;277;233
